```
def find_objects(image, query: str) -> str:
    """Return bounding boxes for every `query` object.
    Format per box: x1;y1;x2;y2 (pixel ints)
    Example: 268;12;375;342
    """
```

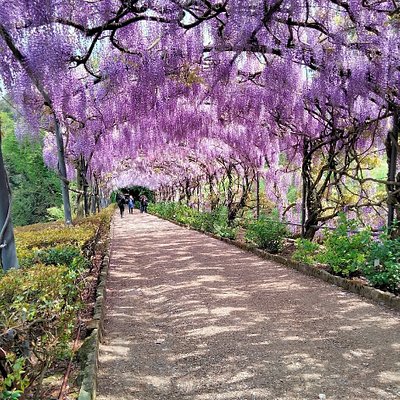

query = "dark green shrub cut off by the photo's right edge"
362;234;400;294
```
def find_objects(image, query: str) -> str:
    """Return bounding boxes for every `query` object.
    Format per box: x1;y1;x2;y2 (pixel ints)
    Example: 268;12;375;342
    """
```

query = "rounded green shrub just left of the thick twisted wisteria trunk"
245;214;289;253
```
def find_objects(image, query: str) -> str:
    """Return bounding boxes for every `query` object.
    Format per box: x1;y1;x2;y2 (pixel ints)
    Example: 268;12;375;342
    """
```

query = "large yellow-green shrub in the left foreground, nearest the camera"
0;264;79;398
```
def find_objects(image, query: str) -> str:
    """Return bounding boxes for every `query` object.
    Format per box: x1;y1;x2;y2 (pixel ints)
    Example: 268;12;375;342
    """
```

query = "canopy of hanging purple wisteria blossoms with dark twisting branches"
0;0;400;269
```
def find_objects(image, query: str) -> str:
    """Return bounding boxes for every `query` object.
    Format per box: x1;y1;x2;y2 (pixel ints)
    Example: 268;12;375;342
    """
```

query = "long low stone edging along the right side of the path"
154;214;400;311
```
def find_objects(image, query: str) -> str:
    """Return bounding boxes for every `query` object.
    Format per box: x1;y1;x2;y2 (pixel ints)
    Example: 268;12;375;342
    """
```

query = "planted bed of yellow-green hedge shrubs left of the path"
0;207;114;400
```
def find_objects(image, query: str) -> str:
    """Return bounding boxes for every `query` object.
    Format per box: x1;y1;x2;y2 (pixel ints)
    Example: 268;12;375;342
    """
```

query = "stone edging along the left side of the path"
78;225;112;400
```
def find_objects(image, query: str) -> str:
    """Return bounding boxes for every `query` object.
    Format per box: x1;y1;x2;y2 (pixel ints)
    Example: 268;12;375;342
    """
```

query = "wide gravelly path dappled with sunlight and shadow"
98;213;400;400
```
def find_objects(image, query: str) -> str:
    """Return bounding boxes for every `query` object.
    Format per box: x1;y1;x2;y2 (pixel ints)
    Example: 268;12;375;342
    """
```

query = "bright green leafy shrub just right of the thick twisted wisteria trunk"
318;213;372;277
